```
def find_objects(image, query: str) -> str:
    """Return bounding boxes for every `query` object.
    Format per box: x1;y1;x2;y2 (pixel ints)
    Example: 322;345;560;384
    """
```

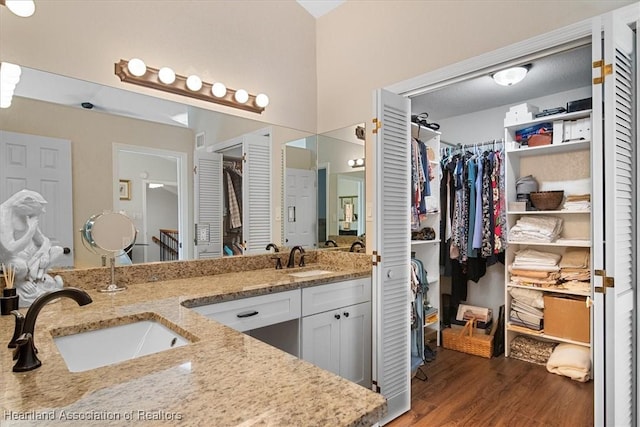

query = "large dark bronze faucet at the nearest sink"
9;288;93;372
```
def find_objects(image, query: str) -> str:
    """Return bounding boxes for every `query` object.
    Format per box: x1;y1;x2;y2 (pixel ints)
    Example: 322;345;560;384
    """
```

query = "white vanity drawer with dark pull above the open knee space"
193;290;301;332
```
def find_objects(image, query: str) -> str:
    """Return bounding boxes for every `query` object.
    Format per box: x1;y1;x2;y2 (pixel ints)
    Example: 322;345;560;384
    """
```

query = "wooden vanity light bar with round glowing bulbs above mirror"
116;59;269;114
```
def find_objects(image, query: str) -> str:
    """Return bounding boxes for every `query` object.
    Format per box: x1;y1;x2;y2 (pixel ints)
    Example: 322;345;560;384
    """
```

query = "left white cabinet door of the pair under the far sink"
302;310;342;375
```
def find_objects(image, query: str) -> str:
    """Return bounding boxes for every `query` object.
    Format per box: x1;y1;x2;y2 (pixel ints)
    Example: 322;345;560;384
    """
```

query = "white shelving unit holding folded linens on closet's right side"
505;110;593;356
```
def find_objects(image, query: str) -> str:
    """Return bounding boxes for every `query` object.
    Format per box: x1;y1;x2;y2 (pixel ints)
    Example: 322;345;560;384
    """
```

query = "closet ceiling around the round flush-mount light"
411;45;591;121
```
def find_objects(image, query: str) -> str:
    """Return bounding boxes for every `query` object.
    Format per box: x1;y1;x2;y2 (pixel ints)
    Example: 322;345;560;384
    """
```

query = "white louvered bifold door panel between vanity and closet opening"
367;90;411;424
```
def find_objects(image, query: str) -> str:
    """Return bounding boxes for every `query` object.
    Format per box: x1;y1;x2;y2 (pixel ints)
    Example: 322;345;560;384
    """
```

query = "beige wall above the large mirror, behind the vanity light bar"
0;0;317;132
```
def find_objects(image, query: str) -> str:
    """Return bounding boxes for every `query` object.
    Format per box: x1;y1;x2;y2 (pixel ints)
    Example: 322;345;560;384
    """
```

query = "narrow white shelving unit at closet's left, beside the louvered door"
411;123;440;346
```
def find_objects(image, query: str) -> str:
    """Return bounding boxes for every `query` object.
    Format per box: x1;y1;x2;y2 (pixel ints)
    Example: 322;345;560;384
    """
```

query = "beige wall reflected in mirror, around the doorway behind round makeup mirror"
0;98;194;267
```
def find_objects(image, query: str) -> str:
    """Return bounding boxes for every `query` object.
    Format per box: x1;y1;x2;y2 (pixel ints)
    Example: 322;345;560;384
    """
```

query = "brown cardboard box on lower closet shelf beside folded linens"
544;294;590;343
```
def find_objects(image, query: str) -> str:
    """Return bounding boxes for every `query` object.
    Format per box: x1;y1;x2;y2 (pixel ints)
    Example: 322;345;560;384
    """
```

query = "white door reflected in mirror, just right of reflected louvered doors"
284;168;316;248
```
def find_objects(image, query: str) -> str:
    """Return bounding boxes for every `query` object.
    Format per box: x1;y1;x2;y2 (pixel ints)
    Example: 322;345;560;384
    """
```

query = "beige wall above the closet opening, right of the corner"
317;0;633;133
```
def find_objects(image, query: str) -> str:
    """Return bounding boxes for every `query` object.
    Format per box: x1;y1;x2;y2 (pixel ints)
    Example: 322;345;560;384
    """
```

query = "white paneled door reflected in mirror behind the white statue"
0;131;73;267
